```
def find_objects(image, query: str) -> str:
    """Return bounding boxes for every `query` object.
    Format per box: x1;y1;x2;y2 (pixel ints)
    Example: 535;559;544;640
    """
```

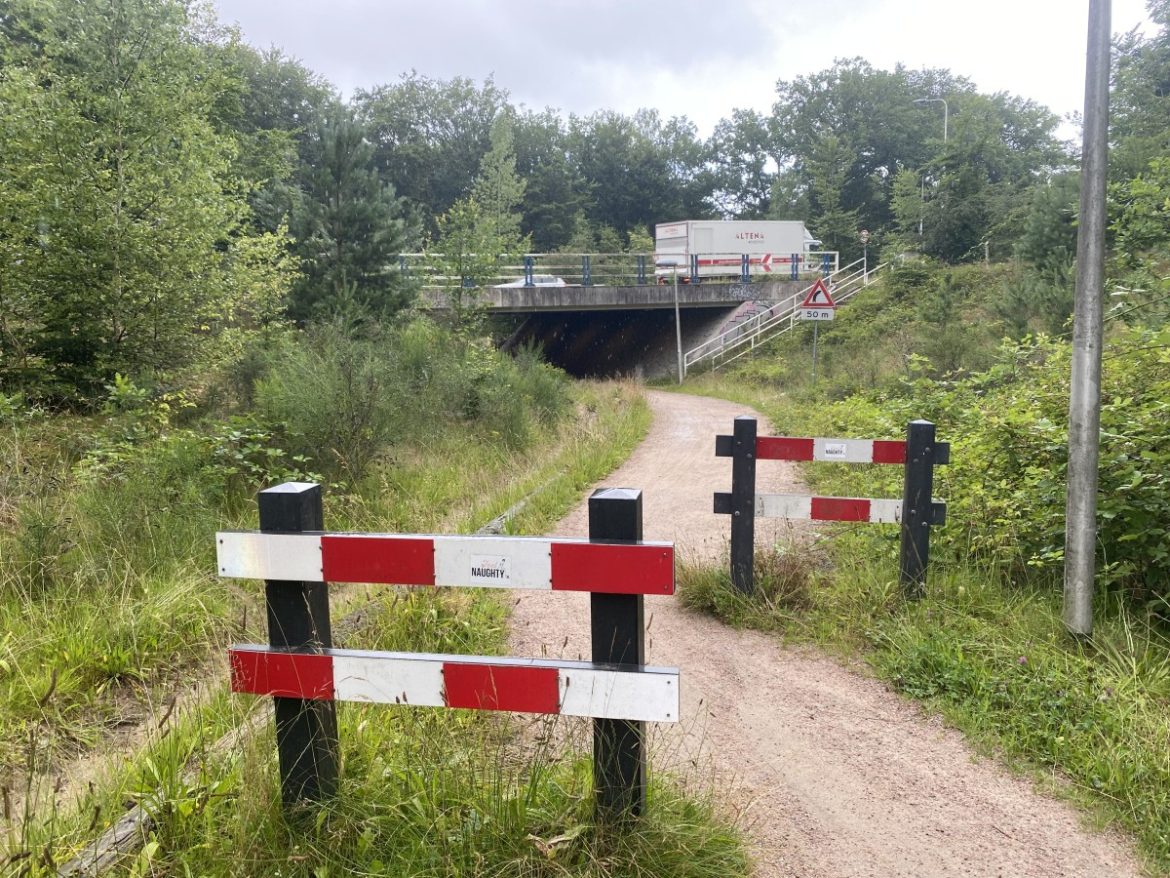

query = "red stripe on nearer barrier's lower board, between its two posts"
442;663;560;713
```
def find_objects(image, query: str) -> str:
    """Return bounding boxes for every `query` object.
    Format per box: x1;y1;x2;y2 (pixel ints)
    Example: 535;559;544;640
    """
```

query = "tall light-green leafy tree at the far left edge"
0;0;292;395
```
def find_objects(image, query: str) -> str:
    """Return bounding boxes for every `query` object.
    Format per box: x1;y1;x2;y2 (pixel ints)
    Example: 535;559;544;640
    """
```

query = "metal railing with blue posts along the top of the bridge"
398;251;838;290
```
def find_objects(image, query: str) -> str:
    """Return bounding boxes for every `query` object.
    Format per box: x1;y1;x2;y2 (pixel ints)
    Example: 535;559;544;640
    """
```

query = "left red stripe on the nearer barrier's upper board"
321;536;435;585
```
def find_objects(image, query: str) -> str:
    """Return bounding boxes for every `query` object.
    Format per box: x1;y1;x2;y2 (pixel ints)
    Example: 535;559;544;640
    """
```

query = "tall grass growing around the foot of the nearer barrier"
52;592;746;878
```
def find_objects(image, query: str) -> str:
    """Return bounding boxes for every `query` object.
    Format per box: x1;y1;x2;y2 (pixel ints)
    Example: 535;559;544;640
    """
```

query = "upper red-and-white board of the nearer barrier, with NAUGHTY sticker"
215;531;674;595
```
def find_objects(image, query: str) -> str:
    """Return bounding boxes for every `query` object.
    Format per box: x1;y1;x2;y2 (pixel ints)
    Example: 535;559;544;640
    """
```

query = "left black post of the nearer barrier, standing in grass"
257;482;338;804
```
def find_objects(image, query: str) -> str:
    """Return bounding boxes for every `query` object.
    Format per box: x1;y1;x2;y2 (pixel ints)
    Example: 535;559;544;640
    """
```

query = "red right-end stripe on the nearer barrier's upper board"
552;543;674;595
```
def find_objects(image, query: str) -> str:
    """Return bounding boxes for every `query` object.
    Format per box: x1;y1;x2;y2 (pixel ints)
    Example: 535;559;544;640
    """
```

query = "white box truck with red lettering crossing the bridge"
654;220;835;283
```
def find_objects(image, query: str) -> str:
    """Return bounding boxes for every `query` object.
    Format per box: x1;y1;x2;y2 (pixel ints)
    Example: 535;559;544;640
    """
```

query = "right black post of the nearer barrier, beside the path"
589;488;646;821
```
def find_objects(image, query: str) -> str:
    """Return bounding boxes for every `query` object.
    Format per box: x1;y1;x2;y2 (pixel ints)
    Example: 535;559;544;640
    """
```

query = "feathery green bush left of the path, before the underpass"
256;320;570;481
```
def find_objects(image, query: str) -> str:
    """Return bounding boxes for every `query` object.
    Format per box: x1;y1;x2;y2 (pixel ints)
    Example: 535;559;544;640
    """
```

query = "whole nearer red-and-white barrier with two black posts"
228;482;679;821
